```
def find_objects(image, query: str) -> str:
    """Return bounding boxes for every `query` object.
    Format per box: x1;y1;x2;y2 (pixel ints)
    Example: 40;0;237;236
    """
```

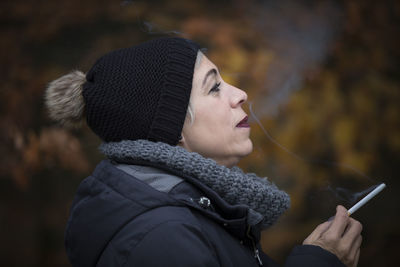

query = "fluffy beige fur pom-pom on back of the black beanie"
45;70;86;127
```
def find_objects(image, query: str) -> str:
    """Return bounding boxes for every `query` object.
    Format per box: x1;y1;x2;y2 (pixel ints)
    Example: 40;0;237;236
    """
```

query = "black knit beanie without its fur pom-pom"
83;38;199;145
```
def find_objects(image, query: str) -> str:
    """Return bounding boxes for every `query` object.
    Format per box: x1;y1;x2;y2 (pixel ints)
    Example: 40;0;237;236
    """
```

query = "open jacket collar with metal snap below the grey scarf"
114;161;263;242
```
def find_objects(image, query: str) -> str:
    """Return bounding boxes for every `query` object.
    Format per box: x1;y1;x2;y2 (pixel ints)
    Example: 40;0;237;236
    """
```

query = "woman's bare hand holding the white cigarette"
303;206;362;267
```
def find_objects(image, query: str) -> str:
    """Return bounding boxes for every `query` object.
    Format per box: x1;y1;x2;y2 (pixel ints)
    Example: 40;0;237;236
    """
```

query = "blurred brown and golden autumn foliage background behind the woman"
0;0;400;266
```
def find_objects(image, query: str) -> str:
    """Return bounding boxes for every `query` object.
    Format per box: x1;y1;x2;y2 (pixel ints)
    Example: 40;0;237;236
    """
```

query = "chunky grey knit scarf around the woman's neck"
100;140;290;228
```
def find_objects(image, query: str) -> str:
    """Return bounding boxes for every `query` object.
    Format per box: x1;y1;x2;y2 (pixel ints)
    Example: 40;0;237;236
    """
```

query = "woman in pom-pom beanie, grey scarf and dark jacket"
46;38;361;266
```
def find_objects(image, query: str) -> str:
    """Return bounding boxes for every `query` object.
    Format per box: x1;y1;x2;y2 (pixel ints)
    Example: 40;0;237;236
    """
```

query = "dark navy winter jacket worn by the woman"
65;160;344;267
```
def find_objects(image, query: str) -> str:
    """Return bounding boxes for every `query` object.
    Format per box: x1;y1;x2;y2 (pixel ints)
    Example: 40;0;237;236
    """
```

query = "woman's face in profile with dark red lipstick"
180;55;253;167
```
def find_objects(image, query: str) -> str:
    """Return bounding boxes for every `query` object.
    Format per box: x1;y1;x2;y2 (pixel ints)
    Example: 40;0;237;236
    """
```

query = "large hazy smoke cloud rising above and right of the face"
248;0;341;116
